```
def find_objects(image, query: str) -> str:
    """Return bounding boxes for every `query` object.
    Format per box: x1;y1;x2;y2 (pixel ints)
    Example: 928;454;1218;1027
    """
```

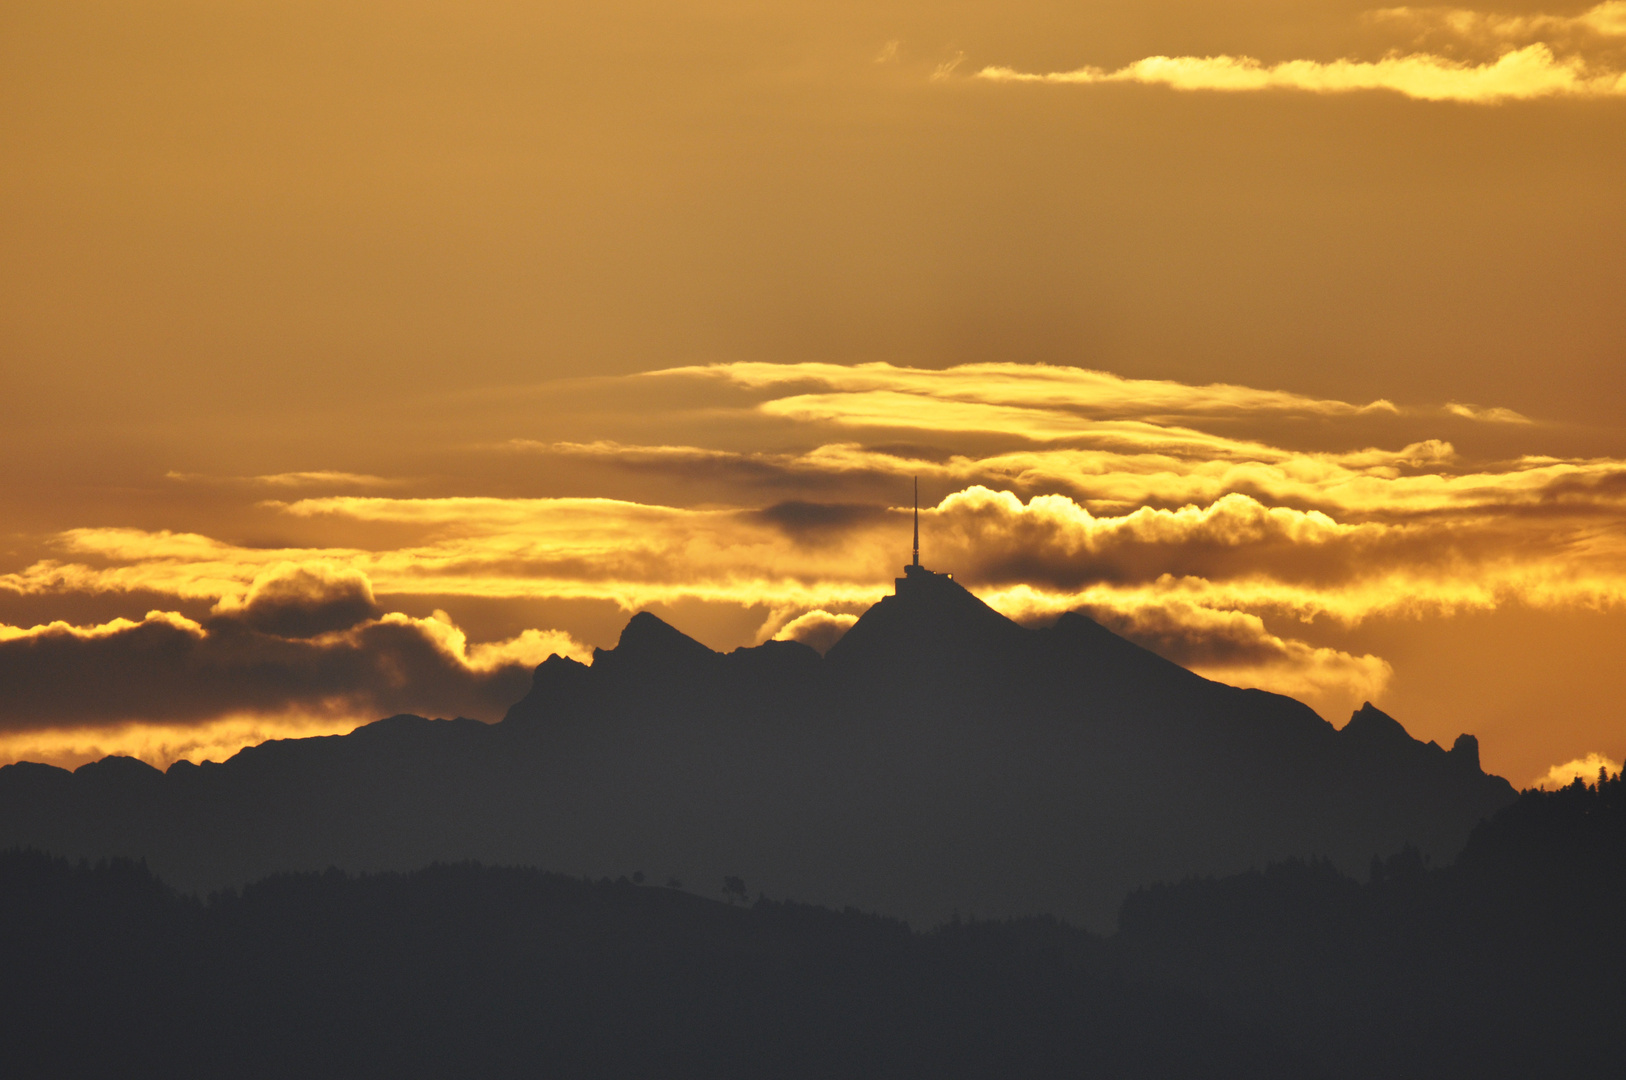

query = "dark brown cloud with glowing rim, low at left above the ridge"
0;561;587;756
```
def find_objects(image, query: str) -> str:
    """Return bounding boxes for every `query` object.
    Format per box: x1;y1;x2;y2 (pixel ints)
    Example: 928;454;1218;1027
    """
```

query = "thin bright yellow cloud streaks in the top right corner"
976;0;1626;104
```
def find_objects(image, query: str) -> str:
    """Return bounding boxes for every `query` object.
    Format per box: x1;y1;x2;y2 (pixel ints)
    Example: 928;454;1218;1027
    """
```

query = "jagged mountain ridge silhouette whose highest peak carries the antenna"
0;568;1514;927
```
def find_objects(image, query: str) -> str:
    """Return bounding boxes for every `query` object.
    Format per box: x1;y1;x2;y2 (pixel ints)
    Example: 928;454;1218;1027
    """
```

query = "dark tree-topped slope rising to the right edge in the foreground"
1114;777;1626;1080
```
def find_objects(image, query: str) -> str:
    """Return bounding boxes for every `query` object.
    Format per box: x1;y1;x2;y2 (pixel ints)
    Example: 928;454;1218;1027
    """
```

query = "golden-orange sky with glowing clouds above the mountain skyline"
0;0;1626;784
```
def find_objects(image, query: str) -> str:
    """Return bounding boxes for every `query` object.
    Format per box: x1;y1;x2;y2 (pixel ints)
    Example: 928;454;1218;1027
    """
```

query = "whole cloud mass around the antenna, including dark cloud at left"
0;357;1626;770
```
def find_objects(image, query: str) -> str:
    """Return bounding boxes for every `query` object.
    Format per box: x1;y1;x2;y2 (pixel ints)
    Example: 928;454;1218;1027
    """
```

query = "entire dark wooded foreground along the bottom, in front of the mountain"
0;779;1626;1080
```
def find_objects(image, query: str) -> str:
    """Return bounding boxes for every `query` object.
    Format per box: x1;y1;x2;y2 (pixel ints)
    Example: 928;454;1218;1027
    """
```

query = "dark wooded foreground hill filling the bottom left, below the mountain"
0;852;1314;1080
